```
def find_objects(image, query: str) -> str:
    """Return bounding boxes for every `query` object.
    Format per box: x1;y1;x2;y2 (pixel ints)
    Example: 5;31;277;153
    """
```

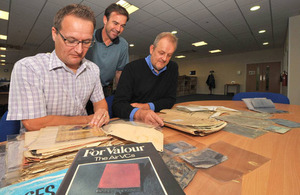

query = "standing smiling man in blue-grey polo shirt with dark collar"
86;3;129;97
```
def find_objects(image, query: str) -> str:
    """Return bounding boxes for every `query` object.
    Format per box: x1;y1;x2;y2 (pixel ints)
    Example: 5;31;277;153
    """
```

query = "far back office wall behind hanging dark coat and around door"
175;48;283;95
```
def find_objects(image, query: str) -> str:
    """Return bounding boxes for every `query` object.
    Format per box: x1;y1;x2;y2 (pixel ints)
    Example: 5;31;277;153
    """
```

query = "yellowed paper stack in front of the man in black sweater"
159;109;227;136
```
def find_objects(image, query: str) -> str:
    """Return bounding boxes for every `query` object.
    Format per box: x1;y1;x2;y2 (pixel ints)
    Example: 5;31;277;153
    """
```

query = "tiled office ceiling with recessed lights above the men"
0;0;300;65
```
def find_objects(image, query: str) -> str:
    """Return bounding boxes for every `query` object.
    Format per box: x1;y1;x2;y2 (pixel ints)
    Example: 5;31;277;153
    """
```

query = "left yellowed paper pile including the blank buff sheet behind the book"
20;120;163;181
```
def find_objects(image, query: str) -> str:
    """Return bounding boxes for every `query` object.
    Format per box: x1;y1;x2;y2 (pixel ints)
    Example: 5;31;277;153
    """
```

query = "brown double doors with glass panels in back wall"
246;62;281;93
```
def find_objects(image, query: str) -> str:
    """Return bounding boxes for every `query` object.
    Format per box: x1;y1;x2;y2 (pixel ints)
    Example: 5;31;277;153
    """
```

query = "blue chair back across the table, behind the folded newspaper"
232;92;290;104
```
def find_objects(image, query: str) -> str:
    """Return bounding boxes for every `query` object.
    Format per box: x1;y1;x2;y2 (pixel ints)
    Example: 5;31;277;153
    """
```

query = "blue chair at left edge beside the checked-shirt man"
0;111;21;142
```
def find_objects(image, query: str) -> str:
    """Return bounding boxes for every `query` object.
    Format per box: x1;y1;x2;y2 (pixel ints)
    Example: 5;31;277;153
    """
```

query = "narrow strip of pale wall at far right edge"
287;15;300;105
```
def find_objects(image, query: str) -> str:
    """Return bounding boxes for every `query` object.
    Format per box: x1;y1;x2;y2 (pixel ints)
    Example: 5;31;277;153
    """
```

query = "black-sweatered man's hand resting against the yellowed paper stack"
134;109;164;127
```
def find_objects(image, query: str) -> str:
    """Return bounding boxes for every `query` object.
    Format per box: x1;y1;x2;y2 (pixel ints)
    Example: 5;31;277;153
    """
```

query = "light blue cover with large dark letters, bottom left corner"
0;169;67;195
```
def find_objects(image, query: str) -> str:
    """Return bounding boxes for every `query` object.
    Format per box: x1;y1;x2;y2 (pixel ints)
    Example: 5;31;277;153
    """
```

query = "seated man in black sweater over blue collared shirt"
112;32;178;126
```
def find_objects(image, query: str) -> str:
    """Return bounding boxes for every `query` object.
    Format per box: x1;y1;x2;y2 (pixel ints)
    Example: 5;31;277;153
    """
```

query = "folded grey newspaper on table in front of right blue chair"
242;98;287;113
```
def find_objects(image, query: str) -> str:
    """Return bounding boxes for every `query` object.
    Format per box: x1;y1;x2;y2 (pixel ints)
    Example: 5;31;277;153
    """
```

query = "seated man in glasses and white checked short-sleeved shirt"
7;4;109;131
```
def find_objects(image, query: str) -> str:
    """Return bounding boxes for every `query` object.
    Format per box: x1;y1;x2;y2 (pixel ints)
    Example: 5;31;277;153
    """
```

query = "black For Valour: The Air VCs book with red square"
57;143;184;195
